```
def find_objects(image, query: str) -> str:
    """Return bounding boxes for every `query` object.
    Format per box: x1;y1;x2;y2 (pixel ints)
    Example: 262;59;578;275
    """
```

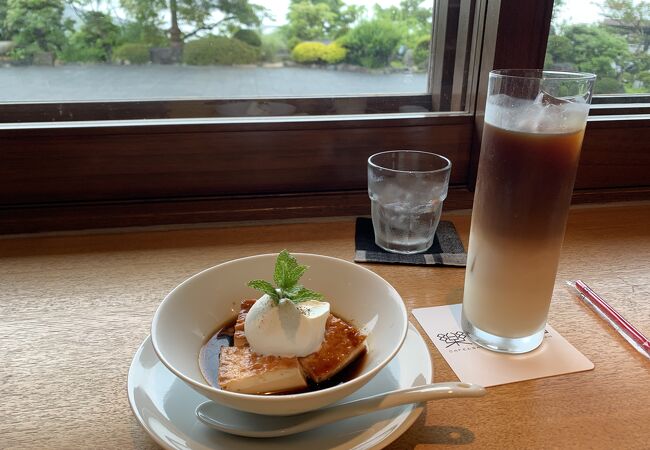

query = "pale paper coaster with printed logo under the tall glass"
413;303;594;387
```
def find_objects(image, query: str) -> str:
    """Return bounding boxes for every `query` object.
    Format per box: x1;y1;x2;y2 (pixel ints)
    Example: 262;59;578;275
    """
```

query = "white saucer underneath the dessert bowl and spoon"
127;324;433;450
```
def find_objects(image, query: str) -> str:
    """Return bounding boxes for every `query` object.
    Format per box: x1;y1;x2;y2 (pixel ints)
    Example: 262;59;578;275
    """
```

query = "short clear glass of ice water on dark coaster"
368;150;451;254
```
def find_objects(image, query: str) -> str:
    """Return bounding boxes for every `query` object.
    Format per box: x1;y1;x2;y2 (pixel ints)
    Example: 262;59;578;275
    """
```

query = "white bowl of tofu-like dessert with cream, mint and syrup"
151;252;408;415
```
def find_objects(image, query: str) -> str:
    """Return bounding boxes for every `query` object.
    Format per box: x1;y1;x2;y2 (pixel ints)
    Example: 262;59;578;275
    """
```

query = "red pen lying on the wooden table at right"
566;280;650;359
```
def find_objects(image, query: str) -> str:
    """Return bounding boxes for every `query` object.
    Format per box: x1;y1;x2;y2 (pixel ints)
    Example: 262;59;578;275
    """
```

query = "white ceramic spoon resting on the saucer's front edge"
196;382;486;438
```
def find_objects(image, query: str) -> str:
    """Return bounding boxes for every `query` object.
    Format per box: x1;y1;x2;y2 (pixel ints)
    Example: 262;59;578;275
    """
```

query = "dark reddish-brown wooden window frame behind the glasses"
0;0;650;233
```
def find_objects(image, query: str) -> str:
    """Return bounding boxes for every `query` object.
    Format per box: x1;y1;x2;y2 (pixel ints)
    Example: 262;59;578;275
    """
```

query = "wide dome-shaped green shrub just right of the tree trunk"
183;36;259;66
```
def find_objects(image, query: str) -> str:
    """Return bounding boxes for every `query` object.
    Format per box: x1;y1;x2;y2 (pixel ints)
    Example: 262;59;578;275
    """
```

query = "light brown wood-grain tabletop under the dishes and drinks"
0;202;650;450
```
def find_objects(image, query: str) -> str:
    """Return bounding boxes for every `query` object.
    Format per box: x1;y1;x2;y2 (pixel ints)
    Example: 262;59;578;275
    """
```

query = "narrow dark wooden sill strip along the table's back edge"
0;187;650;234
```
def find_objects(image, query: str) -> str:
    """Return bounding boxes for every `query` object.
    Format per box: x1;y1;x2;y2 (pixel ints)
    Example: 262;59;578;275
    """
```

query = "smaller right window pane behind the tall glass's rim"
545;0;650;95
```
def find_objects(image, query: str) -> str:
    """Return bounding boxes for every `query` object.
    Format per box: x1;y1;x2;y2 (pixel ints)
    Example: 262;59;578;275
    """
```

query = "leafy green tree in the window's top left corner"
5;0;71;59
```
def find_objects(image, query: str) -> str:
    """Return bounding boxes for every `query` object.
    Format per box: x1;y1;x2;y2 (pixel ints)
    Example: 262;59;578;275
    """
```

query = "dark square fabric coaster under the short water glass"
354;217;467;267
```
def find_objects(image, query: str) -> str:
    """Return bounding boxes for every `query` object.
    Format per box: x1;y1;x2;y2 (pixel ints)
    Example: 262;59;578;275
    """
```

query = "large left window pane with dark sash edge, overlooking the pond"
0;0;476;121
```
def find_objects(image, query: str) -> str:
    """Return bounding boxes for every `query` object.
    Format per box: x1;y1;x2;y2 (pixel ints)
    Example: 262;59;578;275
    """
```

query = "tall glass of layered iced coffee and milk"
462;70;596;353
